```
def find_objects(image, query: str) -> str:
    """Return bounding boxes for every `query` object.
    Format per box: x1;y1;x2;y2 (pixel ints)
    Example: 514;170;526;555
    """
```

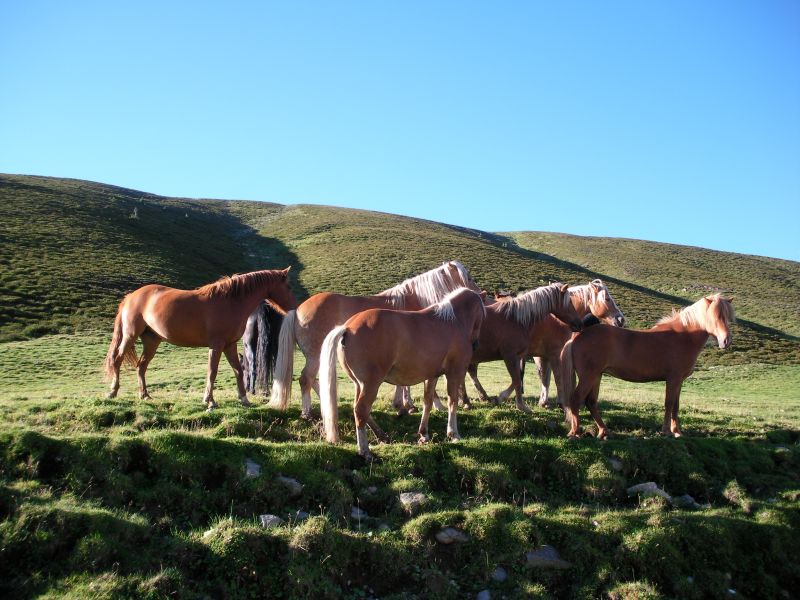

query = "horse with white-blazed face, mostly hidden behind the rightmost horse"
500;279;625;408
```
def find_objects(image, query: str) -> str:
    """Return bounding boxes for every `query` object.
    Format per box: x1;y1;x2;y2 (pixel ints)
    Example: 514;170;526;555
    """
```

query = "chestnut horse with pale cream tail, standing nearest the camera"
320;288;485;460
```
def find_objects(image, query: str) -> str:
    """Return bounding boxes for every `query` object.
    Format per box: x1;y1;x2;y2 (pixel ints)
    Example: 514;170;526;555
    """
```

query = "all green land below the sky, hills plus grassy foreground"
0;175;800;600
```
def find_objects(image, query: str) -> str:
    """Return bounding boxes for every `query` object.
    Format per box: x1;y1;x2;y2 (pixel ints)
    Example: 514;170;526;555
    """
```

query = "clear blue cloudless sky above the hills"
0;0;800;260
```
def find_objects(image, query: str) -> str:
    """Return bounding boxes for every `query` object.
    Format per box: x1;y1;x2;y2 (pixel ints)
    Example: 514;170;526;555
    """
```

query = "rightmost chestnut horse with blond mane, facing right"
562;294;734;439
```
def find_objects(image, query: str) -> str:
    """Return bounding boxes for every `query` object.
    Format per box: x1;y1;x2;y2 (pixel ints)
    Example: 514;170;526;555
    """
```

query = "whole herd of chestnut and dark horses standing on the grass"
105;261;734;459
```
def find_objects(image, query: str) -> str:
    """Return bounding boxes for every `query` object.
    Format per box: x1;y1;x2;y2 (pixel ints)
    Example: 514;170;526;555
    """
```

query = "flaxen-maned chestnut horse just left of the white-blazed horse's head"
444;283;582;412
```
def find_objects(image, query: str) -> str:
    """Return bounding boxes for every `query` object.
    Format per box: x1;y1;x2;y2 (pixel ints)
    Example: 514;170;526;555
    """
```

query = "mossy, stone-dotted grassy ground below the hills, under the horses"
0;334;800;598
